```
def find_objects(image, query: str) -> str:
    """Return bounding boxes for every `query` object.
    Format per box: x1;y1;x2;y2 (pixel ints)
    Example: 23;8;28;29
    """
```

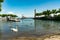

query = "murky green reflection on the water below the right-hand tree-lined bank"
35;20;60;35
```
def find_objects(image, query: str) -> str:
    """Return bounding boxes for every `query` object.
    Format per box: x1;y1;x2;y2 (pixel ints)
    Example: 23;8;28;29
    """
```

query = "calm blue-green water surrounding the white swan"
0;19;60;40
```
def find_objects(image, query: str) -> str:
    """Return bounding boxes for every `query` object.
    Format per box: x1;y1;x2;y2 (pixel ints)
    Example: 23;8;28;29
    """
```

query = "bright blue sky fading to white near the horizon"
0;0;60;17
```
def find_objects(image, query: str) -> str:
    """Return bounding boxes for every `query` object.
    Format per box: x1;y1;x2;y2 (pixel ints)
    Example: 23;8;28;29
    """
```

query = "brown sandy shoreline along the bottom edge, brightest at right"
11;34;60;40
